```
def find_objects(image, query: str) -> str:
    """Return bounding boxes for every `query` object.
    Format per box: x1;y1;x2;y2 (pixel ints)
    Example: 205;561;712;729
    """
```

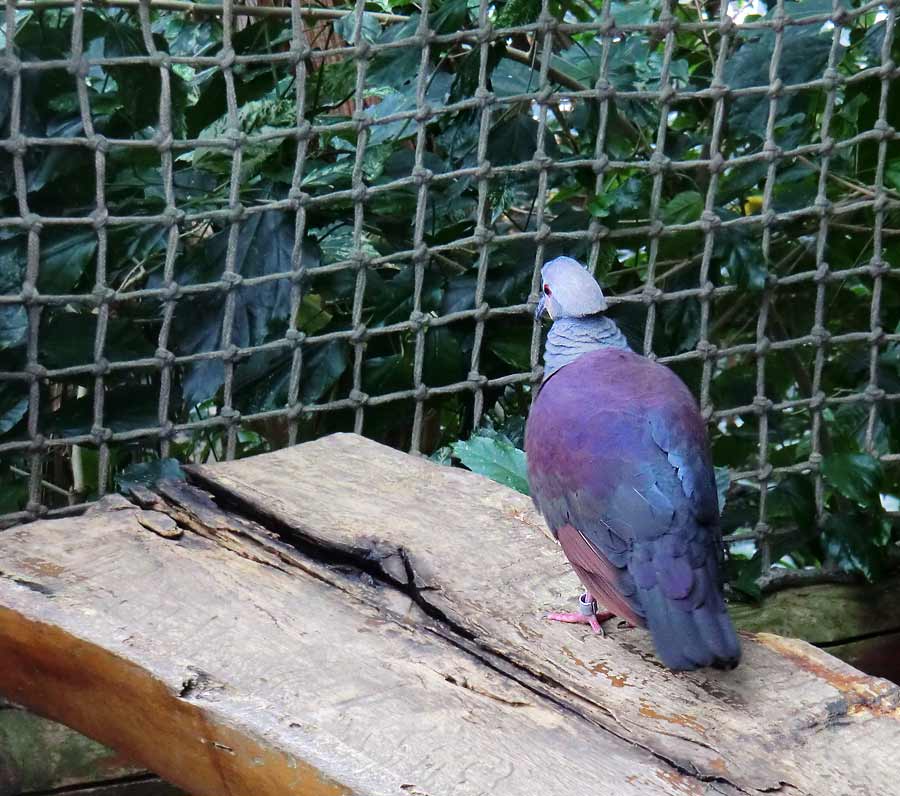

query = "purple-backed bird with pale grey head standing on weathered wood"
525;257;741;670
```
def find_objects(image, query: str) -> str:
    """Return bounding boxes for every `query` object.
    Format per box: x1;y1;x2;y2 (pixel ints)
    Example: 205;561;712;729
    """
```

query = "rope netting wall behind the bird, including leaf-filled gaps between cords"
0;0;900;584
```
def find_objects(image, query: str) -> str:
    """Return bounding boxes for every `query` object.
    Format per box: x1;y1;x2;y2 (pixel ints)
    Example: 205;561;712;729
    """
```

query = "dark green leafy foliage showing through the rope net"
0;0;900;591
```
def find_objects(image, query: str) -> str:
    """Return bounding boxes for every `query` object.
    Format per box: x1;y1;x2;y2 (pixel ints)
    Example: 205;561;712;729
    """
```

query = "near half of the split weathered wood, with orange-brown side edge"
0;490;712;796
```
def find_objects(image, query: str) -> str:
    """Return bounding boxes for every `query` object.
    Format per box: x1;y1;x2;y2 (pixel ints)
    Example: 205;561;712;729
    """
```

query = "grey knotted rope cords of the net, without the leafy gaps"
0;0;900;584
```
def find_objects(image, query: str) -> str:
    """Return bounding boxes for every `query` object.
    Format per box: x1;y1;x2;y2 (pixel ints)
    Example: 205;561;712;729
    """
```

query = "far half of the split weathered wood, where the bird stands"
186;435;900;794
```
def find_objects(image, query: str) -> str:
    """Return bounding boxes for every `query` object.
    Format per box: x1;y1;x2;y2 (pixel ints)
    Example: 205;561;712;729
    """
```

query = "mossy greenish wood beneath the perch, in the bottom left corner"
0;709;141;796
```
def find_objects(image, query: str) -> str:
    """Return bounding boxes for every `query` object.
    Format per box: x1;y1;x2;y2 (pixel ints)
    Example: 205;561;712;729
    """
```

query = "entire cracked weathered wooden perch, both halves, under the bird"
0;435;900;796
